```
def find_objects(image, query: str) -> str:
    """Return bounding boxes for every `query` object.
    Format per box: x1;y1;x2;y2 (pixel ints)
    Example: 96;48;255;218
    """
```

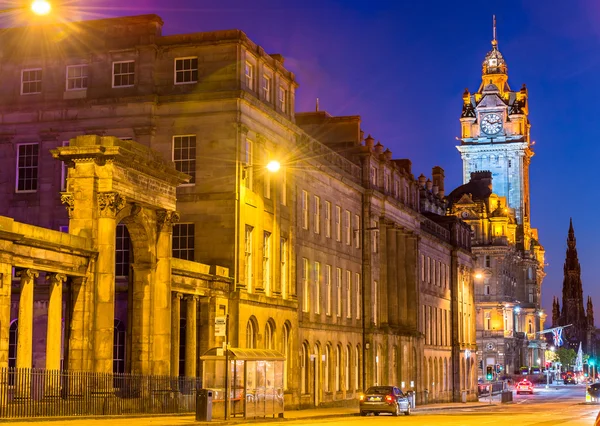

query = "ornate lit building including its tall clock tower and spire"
448;27;546;376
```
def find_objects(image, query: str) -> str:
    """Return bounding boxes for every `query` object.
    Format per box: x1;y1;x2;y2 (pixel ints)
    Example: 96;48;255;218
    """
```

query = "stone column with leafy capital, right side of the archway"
150;210;179;376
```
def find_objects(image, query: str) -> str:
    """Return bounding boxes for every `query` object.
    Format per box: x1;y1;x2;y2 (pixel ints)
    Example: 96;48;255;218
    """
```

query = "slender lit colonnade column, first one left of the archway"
46;274;67;370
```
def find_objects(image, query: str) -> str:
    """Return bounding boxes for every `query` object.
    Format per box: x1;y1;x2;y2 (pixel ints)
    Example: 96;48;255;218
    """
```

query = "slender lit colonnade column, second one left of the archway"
17;269;39;368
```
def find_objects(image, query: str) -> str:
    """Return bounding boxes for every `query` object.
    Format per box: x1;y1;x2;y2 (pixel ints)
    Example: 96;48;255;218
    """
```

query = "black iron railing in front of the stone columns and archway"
0;368;201;419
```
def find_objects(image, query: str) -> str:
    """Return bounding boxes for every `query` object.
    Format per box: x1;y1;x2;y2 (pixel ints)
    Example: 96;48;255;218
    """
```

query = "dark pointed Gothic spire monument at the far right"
552;219;596;358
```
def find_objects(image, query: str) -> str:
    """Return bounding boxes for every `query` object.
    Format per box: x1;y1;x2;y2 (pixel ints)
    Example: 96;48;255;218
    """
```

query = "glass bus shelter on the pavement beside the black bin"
200;348;285;419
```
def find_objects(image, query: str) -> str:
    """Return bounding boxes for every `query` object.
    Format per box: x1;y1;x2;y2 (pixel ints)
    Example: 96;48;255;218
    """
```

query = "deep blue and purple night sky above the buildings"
9;0;600;326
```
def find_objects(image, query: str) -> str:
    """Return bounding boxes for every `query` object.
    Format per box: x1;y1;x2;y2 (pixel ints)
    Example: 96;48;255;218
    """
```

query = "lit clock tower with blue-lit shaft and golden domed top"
457;19;533;232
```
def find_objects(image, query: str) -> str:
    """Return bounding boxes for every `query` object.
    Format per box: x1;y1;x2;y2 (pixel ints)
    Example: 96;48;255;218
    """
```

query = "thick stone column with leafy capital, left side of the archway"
92;192;125;373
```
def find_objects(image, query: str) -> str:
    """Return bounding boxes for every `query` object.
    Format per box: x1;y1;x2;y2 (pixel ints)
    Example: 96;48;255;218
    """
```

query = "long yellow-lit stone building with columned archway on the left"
0;15;476;407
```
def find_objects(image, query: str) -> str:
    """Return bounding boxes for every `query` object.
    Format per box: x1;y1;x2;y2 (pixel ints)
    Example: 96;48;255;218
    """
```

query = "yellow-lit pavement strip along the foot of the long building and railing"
3;398;500;426
